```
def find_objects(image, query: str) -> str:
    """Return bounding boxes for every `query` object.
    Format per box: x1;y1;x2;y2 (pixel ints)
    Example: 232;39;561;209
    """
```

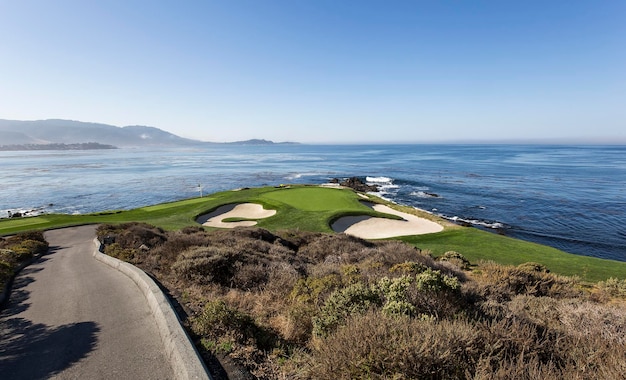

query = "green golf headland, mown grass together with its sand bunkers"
0;185;626;282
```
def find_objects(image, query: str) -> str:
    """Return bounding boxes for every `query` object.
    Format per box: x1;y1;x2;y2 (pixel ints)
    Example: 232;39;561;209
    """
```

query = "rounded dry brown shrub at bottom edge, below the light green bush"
308;311;481;379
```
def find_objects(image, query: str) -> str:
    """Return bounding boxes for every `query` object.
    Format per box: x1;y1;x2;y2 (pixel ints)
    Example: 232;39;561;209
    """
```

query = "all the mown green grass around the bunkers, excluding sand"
0;186;626;282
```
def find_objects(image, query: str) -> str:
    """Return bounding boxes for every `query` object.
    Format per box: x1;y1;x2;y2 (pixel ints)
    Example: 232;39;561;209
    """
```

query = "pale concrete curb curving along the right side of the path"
93;238;212;380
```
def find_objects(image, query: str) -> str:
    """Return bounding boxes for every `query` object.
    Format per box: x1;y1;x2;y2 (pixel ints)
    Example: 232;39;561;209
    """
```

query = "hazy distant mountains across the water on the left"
0;119;296;150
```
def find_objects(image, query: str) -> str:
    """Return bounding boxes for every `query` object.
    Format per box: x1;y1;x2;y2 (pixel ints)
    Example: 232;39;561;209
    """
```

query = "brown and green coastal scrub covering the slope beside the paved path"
98;224;626;379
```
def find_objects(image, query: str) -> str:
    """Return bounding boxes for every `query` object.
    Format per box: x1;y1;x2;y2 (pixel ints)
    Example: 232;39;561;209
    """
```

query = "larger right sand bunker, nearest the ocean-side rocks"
331;204;443;239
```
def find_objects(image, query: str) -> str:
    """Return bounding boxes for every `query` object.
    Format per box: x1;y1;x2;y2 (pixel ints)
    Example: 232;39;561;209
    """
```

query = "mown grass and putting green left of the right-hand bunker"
0;186;380;236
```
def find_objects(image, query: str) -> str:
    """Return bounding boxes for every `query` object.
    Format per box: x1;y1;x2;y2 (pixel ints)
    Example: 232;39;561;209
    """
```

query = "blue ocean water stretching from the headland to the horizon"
0;145;626;261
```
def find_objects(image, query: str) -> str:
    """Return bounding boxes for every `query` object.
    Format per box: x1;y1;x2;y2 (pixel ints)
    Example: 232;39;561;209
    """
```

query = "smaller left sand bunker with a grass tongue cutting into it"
198;203;276;228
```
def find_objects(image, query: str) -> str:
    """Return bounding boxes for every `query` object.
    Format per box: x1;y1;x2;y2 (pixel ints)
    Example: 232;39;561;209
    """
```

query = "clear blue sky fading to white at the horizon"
0;0;626;143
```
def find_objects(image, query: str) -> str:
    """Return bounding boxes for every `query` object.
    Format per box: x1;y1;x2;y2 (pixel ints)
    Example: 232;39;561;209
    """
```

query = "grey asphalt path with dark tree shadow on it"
0;226;174;379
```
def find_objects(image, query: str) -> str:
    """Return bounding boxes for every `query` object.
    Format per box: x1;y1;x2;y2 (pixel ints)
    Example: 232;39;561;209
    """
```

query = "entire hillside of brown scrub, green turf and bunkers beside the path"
0;186;626;380
